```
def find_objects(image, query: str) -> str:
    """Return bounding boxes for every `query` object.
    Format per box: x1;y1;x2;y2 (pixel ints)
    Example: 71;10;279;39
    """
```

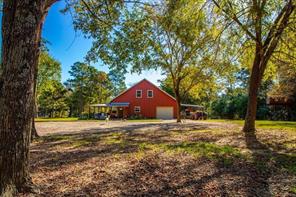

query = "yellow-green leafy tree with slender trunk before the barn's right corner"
75;1;220;122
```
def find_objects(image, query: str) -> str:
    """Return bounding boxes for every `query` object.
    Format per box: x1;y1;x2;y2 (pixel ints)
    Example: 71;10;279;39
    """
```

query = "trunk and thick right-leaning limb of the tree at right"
243;0;296;136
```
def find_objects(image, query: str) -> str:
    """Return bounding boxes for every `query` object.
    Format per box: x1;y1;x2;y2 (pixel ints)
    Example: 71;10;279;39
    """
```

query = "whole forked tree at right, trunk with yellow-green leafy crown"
212;0;295;136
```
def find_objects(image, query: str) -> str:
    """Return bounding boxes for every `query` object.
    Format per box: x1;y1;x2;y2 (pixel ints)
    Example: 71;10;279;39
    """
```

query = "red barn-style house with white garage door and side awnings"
91;79;204;119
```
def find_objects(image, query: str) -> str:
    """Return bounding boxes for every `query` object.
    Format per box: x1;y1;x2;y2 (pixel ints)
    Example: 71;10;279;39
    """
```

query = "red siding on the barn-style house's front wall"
112;79;177;118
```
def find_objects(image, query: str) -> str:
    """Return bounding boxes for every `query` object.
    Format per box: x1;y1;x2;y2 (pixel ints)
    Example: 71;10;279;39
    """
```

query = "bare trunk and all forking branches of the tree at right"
212;0;296;139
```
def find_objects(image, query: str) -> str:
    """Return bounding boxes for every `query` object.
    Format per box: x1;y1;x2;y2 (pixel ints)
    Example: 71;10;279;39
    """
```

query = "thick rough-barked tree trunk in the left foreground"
0;0;54;196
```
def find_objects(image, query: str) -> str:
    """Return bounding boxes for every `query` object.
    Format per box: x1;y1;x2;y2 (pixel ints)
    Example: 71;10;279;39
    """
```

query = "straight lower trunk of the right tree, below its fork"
243;50;262;136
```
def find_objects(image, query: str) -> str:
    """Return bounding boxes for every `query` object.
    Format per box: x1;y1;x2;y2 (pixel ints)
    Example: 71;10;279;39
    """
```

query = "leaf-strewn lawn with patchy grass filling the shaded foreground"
25;120;296;196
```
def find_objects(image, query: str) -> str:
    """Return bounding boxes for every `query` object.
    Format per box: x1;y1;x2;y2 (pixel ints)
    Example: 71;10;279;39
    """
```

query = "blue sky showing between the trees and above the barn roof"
42;1;163;86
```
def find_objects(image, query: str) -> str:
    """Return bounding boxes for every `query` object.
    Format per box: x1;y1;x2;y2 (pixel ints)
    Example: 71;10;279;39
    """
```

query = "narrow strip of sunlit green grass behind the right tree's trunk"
205;119;296;131
